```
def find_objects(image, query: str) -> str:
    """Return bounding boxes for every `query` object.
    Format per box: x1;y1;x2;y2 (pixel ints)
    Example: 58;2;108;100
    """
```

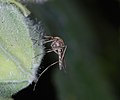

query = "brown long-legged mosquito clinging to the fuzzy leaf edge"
34;36;67;90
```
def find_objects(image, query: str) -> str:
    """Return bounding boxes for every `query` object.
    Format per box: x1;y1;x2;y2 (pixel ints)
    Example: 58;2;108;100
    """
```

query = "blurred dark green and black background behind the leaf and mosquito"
13;0;120;100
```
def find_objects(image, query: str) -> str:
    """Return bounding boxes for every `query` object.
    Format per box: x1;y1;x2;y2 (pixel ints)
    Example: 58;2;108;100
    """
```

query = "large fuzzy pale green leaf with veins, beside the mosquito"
0;0;43;97
